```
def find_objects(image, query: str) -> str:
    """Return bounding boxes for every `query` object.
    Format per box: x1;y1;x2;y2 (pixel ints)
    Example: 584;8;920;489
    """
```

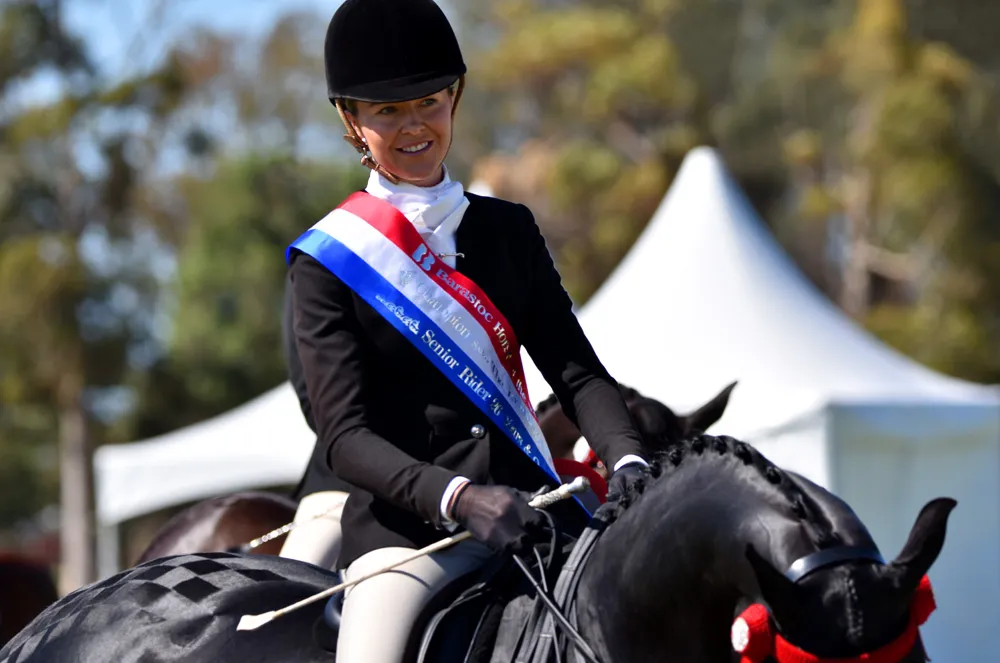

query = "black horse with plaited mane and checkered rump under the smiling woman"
0;436;955;663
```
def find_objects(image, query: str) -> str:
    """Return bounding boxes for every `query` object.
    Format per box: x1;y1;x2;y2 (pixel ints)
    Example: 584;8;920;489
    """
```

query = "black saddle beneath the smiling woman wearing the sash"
317;498;617;663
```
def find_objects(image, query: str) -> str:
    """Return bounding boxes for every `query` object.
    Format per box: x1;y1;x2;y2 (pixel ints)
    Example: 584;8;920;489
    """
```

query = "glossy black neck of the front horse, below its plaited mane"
578;466;797;662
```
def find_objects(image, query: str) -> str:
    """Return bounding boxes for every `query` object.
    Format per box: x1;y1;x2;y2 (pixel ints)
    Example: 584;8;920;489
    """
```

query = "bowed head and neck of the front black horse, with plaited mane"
577;435;956;663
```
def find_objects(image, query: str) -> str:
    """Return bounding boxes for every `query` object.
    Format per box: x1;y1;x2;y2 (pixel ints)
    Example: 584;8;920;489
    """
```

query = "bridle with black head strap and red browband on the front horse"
731;546;936;663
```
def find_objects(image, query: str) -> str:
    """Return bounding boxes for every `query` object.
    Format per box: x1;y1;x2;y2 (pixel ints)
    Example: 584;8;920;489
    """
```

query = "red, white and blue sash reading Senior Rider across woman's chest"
286;191;586;510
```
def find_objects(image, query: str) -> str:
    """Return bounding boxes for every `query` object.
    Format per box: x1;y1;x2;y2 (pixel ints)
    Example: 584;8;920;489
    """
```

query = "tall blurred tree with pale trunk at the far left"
0;0;205;590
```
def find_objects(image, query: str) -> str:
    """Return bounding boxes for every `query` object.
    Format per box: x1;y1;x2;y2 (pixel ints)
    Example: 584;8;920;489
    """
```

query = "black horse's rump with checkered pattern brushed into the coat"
0;553;338;663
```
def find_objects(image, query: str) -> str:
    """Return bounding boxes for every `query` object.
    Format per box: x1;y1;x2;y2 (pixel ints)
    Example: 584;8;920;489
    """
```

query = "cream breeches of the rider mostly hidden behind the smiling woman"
279;490;347;570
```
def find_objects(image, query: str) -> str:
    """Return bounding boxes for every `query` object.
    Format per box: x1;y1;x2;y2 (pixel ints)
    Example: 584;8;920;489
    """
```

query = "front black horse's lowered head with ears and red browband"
748;499;956;663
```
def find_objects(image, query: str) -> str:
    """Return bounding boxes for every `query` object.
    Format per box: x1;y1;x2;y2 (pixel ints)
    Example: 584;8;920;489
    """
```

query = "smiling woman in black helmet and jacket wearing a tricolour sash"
288;0;648;663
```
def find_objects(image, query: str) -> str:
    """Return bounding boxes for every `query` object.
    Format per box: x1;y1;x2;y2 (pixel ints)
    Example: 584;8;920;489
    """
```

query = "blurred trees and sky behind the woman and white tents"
0;0;1000;628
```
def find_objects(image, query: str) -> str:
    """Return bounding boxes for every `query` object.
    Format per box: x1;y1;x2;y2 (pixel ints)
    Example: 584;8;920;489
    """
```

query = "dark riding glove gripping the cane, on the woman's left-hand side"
452;484;546;555
